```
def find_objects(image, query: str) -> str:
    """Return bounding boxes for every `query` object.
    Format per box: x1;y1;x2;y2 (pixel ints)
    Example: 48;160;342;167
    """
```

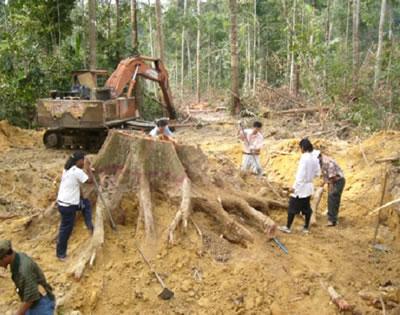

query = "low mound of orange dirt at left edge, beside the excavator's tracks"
0;120;42;151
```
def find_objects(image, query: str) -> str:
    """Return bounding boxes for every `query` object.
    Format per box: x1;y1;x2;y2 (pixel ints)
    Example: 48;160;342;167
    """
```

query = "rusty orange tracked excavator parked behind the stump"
37;56;177;150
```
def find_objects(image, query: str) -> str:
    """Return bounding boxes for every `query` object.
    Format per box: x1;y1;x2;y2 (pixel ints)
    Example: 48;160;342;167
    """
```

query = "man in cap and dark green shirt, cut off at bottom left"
0;240;55;315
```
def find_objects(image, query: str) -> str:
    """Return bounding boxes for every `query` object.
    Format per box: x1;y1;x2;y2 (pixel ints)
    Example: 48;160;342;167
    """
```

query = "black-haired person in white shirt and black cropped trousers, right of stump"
279;139;321;233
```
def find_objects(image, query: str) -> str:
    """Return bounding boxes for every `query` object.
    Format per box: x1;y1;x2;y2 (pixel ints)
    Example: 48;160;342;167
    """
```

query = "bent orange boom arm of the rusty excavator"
105;56;177;119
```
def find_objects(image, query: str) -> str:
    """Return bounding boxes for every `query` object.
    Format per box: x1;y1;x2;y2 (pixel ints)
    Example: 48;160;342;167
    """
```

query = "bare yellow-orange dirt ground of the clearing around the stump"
0;122;400;315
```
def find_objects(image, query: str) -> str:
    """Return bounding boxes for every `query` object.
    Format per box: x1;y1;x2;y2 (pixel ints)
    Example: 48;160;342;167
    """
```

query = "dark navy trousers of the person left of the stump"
57;199;93;258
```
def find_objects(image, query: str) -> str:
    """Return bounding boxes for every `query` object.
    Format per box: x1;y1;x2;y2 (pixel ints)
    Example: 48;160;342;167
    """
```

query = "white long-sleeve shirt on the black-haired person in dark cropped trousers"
293;152;321;198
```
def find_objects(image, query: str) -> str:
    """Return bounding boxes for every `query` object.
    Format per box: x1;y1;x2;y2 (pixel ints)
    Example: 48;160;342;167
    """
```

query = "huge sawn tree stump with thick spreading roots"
82;131;276;252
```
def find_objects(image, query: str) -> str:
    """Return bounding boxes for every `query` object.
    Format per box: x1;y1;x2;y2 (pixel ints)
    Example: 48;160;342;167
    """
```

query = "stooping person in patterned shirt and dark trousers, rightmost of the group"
318;154;346;227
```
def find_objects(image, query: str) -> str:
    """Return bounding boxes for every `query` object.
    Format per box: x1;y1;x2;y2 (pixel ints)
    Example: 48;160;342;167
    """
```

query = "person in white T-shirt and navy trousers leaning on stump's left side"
56;151;93;260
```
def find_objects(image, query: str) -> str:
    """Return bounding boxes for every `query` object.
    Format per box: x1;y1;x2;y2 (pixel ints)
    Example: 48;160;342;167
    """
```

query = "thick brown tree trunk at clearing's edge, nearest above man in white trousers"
229;0;240;114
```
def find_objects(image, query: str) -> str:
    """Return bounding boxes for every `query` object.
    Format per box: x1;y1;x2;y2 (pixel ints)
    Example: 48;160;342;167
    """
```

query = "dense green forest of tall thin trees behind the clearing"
0;0;400;131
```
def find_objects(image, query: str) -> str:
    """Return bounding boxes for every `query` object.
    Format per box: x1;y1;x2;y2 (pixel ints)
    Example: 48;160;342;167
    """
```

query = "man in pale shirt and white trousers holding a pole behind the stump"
239;121;264;174
